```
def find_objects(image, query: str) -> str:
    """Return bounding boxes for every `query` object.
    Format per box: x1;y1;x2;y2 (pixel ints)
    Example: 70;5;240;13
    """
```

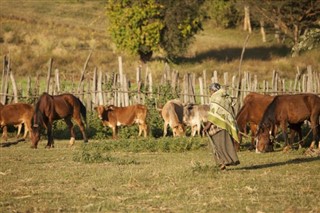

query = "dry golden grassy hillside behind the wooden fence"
0;0;320;82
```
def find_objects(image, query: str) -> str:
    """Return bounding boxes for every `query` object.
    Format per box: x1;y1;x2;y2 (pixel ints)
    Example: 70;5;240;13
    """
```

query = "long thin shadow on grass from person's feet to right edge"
230;157;320;170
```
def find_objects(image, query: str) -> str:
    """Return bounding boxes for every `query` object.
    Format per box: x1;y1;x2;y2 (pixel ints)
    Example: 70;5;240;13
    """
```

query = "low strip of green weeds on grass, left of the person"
73;137;207;164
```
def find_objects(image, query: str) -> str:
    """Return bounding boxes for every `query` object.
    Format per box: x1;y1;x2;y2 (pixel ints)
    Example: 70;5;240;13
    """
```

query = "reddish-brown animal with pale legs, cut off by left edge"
0;103;33;141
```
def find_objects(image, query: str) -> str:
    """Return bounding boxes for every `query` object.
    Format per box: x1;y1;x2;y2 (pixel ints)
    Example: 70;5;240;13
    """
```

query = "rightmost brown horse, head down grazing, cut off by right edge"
256;93;320;152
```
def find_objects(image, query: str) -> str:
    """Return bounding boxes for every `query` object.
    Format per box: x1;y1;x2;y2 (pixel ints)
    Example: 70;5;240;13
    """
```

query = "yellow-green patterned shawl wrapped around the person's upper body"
208;88;239;143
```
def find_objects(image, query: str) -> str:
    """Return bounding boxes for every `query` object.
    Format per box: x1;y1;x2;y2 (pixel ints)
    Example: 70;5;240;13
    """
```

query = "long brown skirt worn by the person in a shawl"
211;129;240;166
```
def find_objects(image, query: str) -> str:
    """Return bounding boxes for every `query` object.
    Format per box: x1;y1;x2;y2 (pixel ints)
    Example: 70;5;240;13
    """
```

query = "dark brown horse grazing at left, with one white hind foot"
31;93;88;148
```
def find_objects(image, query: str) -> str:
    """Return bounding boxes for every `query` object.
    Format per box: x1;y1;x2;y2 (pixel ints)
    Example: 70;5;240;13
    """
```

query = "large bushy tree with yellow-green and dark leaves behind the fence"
107;0;203;61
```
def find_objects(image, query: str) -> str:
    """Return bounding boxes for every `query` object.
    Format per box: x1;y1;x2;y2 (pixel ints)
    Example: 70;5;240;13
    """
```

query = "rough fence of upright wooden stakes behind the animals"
0;53;320;111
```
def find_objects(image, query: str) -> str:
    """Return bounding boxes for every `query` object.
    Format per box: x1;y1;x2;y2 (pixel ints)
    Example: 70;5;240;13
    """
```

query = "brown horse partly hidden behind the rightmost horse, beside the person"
236;92;302;149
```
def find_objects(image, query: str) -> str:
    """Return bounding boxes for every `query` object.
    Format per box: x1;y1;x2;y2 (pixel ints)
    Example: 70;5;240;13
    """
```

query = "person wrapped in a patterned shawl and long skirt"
204;83;240;170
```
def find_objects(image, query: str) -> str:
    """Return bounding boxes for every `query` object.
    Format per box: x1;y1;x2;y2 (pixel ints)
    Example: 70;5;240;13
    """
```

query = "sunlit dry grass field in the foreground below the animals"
0;138;320;212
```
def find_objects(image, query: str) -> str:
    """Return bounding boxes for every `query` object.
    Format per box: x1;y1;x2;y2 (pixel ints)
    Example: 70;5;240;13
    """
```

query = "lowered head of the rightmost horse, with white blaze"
256;125;273;153
